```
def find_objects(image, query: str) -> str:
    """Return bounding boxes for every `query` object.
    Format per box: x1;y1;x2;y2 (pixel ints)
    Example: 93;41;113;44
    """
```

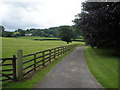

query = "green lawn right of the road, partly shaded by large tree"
85;47;118;88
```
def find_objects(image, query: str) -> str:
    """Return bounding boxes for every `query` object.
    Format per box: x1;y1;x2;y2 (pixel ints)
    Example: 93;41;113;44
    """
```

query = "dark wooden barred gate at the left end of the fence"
0;55;17;81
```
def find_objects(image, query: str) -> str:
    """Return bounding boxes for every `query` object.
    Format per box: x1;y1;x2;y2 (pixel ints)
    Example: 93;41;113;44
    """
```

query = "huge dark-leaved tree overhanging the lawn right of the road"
74;2;120;48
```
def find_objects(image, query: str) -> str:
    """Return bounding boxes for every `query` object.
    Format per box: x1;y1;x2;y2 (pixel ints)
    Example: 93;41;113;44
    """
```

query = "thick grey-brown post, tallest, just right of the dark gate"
17;50;23;81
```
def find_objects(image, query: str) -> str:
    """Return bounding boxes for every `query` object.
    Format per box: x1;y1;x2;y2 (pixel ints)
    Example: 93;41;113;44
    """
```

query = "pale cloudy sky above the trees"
0;0;85;31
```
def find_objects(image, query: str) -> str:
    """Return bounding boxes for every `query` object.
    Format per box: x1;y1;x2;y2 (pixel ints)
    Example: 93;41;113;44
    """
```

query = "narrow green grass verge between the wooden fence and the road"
3;46;78;88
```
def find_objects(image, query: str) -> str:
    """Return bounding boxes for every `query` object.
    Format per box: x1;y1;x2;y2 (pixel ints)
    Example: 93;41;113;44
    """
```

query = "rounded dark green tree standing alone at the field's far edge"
59;26;74;44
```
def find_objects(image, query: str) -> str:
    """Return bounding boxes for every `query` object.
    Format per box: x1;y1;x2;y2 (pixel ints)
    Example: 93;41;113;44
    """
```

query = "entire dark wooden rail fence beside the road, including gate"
0;44;78;81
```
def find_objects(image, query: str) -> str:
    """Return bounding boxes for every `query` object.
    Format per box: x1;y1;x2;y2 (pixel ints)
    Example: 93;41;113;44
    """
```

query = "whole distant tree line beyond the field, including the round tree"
0;25;80;44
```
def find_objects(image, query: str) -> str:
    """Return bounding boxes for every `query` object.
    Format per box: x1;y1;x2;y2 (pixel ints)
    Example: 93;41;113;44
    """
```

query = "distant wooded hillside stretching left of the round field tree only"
0;26;58;37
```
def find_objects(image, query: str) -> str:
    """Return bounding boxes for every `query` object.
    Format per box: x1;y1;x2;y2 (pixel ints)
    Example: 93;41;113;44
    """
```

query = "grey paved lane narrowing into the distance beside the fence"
34;46;103;89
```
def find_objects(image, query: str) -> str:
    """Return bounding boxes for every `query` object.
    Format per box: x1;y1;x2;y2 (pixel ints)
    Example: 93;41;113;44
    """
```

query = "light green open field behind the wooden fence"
2;37;84;58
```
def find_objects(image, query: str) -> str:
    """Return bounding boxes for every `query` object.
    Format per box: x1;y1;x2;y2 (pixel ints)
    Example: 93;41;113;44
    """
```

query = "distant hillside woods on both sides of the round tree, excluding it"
0;26;79;39
